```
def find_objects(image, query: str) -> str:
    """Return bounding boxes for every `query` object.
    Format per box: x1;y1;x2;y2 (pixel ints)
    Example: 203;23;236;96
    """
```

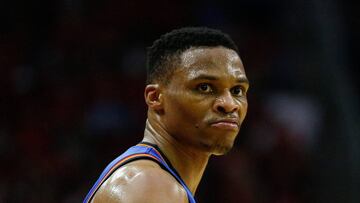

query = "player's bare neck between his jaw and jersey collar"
143;121;210;194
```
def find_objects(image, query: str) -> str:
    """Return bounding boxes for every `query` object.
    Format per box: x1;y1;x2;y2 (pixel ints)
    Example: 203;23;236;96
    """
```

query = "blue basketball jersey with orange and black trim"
83;142;196;203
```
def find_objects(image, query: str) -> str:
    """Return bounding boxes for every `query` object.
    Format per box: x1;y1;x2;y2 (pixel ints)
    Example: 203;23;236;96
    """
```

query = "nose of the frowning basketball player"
213;91;240;114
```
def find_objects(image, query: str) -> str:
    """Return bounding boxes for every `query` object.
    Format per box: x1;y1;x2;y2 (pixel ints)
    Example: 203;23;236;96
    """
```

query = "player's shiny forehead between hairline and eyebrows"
176;46;245;77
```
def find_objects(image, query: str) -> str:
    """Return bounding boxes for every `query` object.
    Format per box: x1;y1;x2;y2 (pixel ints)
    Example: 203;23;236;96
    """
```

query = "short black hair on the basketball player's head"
146;27;238;84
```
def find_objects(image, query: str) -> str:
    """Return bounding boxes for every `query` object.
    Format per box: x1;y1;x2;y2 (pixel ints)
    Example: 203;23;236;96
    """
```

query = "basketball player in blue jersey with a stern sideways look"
84;27;249;203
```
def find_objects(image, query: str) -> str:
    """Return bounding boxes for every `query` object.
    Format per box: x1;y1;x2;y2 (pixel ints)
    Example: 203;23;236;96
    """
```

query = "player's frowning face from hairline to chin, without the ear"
161;46;249;154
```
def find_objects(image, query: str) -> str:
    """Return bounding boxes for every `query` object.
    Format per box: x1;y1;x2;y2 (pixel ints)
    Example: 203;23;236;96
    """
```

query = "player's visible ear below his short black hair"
144;84;163;112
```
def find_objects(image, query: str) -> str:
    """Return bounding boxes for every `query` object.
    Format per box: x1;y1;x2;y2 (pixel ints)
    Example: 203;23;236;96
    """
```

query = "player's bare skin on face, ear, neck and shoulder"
93;46;249;203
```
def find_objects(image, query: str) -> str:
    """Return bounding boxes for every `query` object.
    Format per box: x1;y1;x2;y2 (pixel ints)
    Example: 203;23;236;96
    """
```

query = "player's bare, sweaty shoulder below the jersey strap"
93;160;187;203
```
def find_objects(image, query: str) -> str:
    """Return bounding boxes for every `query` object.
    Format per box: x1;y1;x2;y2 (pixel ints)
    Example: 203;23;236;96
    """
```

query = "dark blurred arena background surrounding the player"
0;0;360;203
